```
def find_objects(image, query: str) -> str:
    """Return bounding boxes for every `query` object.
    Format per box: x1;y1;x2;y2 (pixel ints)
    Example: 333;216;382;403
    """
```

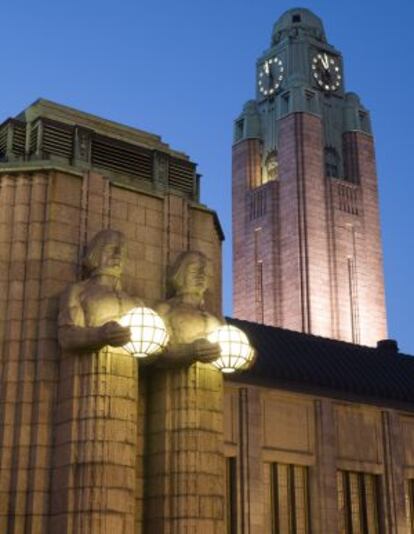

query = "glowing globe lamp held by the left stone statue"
118;307;169;358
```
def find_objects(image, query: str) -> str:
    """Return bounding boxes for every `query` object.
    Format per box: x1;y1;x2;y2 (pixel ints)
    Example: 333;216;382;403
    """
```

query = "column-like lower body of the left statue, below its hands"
50;348;138;534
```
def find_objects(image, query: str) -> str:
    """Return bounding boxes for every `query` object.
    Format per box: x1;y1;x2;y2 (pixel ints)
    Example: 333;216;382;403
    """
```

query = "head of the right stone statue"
169;251;208;296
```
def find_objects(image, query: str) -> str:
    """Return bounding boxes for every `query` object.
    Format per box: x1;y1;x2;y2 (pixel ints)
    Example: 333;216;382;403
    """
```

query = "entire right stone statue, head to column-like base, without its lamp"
146;251;225;533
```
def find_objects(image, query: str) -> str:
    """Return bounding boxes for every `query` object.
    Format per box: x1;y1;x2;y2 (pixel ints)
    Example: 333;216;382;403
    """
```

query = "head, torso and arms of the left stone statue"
59;230;143;352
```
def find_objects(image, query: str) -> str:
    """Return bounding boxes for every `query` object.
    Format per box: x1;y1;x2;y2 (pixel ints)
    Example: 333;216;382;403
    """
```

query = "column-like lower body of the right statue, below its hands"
145;363;225;534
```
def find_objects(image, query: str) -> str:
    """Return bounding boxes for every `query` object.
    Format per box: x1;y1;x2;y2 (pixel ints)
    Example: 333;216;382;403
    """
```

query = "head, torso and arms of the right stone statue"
156;251;222;366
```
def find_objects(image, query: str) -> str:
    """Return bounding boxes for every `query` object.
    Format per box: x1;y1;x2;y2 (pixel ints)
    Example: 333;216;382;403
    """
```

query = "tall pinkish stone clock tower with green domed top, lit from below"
233;9;387;345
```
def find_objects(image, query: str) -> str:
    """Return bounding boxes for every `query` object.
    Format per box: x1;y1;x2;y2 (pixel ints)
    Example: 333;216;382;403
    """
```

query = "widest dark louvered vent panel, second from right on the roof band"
92;135;153;181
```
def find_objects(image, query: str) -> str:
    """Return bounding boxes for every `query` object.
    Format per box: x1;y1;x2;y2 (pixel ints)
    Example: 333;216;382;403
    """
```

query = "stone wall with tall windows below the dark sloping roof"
224;382;414;534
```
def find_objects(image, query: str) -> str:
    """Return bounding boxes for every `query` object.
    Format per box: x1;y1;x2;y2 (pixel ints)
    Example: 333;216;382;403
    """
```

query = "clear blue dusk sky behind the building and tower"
0;0;414;354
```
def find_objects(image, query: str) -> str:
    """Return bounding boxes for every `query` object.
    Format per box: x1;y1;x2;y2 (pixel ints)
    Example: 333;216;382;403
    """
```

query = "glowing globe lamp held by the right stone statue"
207;325;254;373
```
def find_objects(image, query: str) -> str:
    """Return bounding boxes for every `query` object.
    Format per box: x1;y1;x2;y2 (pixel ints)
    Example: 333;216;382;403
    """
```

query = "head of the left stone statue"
83;230;126;278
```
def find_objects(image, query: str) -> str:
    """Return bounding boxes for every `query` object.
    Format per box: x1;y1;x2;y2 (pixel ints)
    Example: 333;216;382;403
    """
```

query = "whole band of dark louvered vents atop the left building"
0;116;198;200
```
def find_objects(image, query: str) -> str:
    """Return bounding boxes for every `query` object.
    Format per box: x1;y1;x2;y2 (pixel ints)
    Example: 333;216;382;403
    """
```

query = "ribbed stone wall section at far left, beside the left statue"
0;173;61;533
